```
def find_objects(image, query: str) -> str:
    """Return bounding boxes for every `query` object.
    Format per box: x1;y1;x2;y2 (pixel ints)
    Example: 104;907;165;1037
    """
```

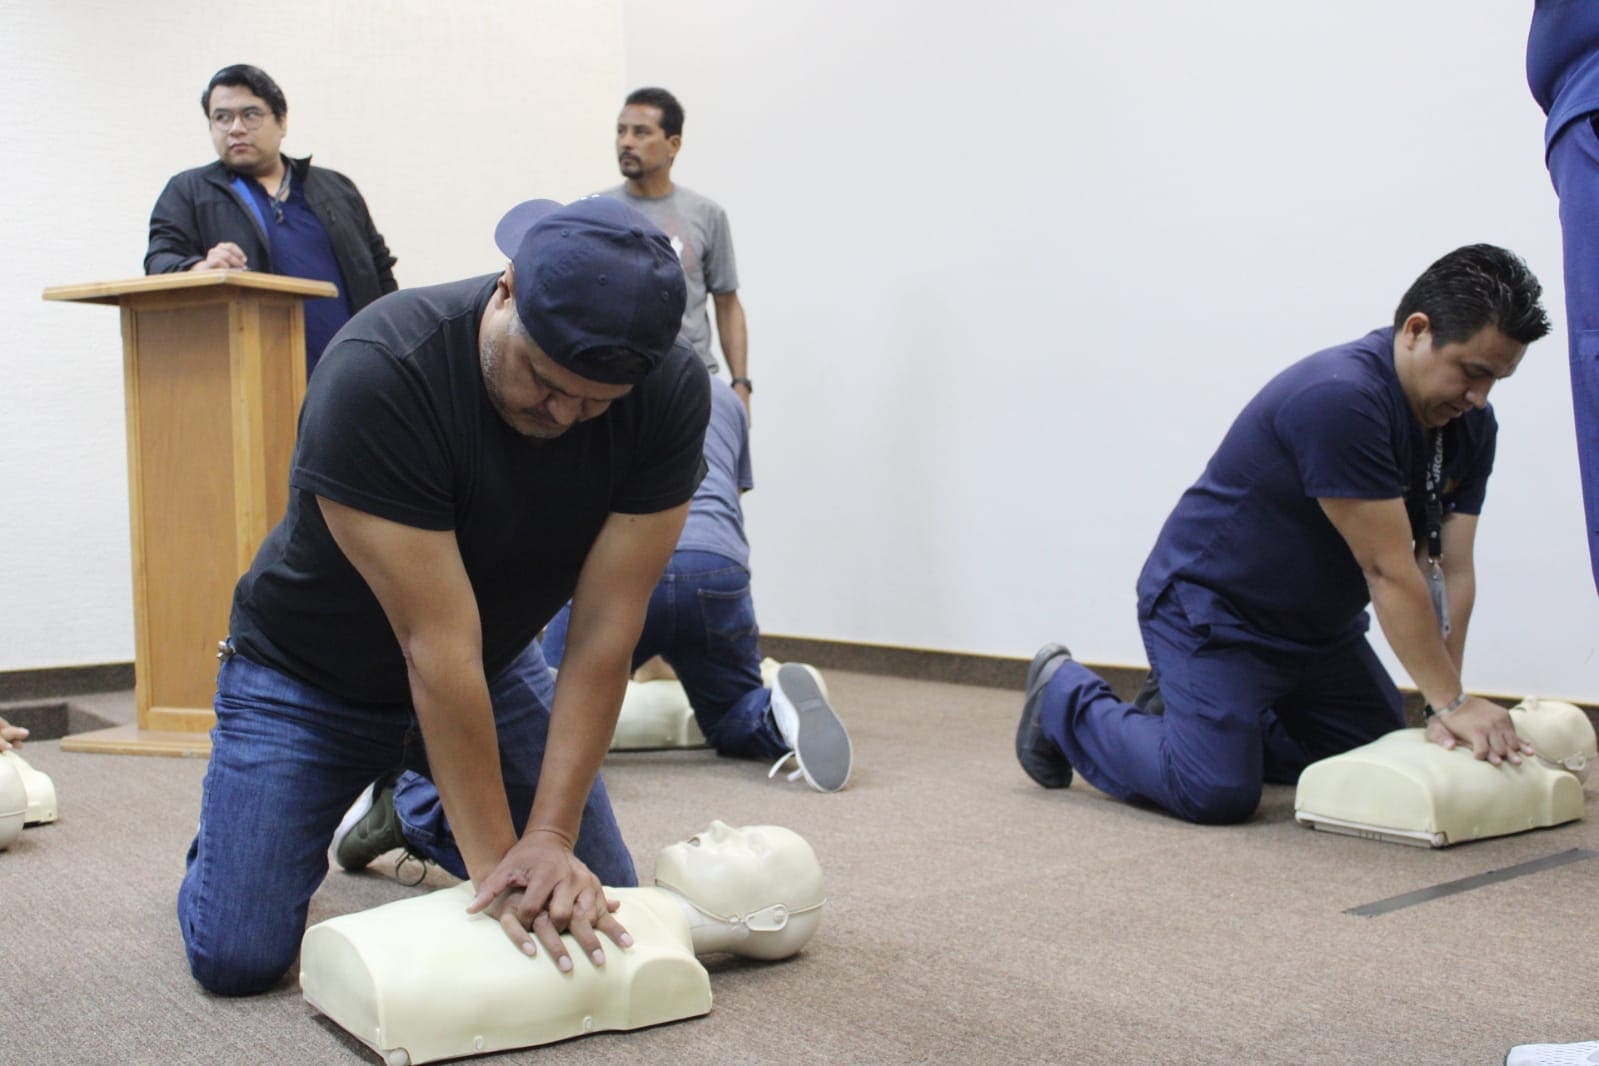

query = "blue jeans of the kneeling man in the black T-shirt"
177;644;638;996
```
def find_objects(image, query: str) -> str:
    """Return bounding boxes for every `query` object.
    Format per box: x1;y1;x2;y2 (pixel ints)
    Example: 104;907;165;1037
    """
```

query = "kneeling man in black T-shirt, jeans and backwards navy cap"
177;198;710;994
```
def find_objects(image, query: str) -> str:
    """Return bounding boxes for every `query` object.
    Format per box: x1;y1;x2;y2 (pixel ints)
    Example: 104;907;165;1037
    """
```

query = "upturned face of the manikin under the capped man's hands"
656;821;823;924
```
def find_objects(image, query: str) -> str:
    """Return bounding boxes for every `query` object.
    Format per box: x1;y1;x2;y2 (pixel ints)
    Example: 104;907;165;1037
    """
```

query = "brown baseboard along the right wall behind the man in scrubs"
761;633;1599;730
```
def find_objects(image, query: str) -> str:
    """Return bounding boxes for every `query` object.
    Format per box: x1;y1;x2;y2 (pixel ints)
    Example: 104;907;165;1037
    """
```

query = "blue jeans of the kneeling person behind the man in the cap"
544;551;788;759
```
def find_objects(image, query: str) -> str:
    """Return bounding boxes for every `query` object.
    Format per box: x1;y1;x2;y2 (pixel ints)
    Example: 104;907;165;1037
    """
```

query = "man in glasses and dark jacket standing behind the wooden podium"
144;64;398;372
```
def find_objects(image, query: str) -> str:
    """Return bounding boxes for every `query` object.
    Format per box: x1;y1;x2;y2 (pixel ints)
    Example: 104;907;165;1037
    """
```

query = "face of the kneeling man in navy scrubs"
1394;313;1527;430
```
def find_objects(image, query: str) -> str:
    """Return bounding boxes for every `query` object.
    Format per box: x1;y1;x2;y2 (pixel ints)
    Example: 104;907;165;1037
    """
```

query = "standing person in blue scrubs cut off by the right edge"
1527;0;1599;588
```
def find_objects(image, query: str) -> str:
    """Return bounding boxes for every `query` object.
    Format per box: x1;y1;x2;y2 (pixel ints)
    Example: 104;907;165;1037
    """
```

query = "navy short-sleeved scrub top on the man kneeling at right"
1138;328;1498;650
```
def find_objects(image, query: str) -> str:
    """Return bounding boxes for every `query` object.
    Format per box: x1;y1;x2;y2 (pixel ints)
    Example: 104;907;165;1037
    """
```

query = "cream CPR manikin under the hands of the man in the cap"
301;821;823;1066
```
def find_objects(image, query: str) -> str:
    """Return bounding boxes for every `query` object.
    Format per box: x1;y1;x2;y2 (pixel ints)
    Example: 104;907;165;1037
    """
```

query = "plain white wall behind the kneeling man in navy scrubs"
624;0;1599;700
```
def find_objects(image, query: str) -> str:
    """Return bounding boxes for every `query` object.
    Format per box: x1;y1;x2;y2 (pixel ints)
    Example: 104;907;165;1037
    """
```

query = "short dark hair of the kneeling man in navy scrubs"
1394;245;1549;345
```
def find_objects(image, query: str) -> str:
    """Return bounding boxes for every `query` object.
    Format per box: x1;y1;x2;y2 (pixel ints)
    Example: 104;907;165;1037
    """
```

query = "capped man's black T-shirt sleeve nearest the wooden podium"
289;340;456;529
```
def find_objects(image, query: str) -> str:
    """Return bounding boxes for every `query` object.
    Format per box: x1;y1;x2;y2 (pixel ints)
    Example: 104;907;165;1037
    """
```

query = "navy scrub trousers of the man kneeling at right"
1039;587;1404;823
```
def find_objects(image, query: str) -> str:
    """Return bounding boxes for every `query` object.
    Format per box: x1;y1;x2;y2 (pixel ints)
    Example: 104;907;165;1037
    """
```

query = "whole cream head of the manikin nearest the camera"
656;821;827;959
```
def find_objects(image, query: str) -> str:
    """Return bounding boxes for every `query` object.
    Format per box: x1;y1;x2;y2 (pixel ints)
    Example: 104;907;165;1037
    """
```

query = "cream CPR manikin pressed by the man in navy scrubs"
1294;700;1596;847
